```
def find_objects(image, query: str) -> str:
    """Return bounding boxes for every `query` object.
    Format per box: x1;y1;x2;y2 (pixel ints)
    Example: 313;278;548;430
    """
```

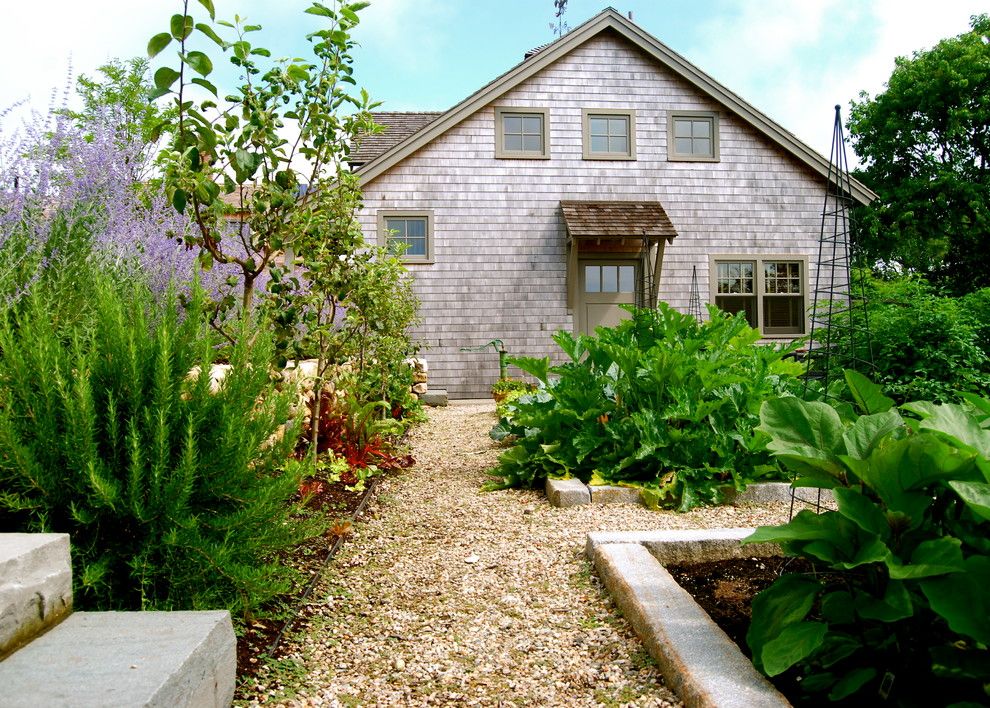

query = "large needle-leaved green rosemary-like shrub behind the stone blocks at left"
0;268;316;615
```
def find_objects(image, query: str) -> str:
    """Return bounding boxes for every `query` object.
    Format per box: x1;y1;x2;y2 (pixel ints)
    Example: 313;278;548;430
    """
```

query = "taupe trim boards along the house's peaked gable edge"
357;8;877;204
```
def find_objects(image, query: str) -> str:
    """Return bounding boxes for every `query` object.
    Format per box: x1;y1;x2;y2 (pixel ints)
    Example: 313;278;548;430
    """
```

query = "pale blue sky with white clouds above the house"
0;0;988;156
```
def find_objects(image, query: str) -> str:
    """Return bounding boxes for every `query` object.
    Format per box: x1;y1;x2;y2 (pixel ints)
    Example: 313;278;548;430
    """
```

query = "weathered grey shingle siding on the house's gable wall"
360;11;876;398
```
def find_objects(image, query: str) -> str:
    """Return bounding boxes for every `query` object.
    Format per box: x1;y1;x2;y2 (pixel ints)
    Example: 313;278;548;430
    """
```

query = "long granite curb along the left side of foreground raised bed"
594;543;790;708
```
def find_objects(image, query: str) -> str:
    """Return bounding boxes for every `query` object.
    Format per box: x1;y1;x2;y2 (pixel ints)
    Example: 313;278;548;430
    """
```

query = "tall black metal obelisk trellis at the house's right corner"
791;106;875;516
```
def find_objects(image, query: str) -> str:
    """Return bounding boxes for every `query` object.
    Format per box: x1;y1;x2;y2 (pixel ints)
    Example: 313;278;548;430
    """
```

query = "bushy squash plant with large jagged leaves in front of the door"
493;304;802;509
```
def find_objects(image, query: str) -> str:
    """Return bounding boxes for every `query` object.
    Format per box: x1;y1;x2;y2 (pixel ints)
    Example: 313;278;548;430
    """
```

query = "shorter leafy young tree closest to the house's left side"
266;170;418;449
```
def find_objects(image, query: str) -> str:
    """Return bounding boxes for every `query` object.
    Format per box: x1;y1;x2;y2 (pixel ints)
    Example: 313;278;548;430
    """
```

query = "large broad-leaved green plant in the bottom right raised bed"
747;372;990;705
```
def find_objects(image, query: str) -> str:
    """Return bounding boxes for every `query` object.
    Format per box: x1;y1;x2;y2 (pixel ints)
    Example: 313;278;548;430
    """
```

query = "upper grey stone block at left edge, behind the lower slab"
0;533;72;659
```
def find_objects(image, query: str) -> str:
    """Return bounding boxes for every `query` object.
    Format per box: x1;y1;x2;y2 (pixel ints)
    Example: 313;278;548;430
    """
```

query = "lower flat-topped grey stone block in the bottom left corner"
0;611;237;708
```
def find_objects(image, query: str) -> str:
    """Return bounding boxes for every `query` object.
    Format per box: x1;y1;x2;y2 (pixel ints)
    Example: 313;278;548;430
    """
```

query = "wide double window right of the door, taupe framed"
714;258;806;335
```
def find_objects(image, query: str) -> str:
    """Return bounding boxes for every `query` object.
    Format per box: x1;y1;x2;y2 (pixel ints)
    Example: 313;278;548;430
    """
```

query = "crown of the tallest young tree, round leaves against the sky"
148;0;376;315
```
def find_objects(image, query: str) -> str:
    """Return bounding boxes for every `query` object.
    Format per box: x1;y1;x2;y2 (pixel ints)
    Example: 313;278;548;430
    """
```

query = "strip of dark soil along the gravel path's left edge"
237;481;375;681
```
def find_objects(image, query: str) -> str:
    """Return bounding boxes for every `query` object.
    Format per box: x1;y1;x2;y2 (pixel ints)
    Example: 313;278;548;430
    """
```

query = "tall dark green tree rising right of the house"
849;15;990;293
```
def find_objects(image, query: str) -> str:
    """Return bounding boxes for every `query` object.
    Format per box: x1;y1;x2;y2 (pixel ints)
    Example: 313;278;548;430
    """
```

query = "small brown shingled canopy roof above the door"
560;201;677;241
